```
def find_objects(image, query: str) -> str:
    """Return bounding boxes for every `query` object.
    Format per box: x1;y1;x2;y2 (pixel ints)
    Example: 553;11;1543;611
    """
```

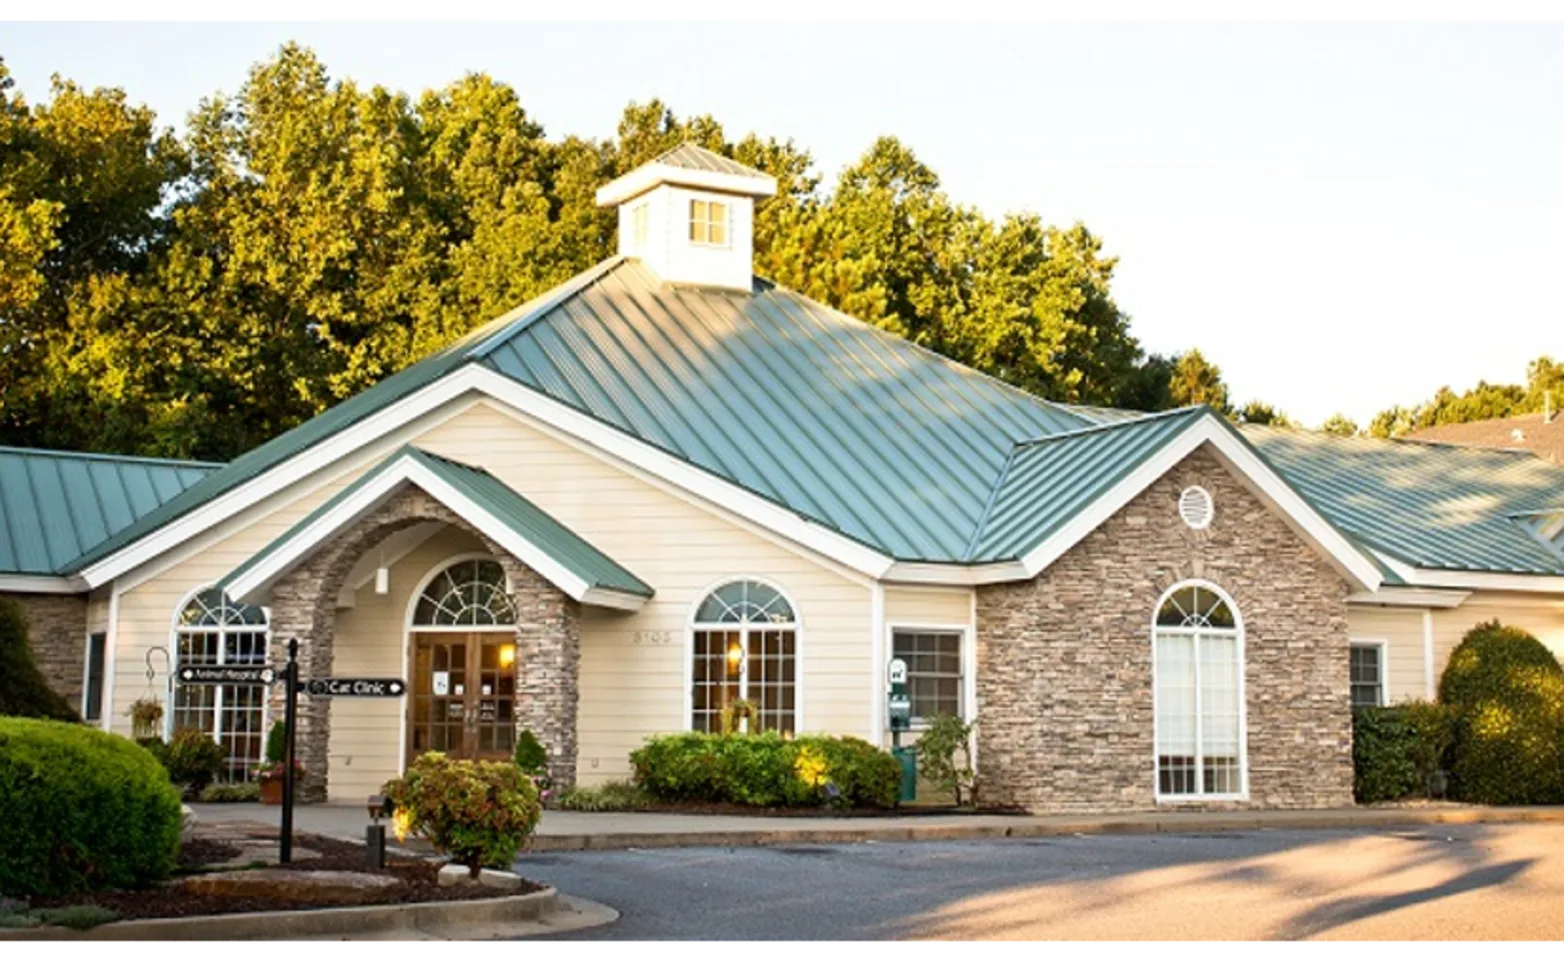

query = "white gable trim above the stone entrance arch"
221;452;647;610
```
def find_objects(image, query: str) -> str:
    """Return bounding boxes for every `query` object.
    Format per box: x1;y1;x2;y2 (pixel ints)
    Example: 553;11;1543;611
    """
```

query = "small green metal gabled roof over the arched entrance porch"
219;447;652;597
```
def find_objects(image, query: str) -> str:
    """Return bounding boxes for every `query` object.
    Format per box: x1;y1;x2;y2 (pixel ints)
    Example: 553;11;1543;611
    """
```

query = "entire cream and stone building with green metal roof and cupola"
0;145;1564;810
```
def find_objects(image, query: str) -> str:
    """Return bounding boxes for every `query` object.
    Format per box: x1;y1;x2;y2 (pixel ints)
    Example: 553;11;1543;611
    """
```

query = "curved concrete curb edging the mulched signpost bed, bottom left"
0;887;560;944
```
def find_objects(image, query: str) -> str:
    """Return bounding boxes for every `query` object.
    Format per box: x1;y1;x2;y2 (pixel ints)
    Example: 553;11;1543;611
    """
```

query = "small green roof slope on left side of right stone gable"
967;407;1211;561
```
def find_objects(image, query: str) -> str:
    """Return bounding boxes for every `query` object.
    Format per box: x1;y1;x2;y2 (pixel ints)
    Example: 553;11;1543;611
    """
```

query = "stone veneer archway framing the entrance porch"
271;486;580;801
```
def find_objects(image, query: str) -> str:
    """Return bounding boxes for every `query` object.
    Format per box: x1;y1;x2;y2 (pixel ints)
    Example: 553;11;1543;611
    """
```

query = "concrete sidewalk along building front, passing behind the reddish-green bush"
192;804;1564;852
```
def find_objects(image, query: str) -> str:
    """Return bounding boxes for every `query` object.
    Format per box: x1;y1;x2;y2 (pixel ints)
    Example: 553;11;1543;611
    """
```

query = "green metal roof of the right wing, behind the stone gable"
1242;427;1564;574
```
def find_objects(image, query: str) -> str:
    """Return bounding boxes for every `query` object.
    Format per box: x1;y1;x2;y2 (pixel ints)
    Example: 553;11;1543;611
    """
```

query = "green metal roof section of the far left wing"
0;447;219;575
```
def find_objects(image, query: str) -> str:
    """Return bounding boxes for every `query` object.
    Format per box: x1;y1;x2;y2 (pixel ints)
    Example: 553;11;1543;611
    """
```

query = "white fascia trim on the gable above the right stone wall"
1021;413;1384;591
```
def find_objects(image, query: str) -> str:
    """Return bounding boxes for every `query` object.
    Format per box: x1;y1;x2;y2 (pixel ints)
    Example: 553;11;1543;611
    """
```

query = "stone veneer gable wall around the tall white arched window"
978;447;1353;811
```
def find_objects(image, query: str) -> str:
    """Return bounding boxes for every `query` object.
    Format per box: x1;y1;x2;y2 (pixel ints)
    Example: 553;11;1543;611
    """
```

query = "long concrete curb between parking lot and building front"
522;807;1564;857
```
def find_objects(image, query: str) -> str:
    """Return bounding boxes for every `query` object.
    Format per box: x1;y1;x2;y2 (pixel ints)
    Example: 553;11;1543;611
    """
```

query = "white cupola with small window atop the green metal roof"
597;144;777;291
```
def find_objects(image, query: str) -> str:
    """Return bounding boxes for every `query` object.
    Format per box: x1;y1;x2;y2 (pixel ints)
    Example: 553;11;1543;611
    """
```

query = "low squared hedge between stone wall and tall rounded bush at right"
1353;702;1453;804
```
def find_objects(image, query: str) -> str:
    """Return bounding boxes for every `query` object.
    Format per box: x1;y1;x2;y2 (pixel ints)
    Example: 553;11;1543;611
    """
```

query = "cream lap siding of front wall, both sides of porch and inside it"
114;402;871;801
